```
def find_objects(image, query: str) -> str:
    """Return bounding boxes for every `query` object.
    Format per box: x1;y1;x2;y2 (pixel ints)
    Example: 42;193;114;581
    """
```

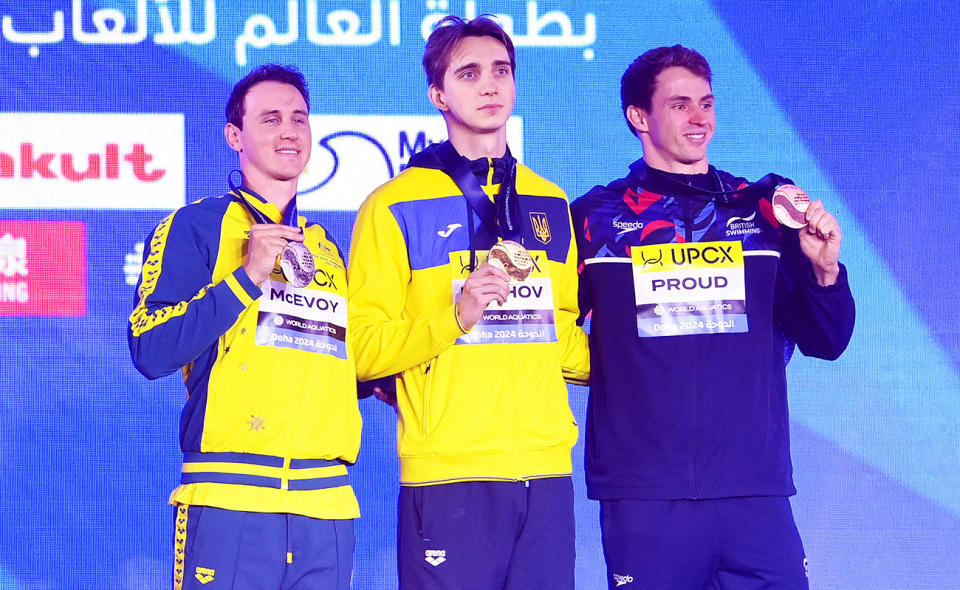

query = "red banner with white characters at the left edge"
0;221;87;316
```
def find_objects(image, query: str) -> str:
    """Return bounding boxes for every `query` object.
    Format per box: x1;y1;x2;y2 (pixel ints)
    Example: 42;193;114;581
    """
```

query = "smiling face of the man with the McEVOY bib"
226;81;313;186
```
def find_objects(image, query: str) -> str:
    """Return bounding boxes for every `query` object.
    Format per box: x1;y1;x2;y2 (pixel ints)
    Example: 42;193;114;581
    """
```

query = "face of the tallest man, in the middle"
430;37;517;139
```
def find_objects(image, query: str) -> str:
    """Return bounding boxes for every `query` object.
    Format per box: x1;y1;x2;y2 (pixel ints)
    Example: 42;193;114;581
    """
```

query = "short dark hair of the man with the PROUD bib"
620;45;711;135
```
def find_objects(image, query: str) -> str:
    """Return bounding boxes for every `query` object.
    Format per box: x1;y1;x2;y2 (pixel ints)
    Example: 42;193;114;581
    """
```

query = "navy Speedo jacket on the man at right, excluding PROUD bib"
571;160;855;500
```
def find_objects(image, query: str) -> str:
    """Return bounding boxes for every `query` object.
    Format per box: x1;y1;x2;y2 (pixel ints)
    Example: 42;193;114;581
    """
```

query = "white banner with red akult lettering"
0;113;186;209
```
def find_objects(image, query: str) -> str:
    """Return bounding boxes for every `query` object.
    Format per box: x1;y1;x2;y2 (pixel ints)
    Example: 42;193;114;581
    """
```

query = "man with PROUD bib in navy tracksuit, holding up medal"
571;45;855;590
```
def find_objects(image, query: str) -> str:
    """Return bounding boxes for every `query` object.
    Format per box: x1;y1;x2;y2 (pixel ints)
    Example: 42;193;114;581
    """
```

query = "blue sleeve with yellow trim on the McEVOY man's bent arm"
127;209;260;379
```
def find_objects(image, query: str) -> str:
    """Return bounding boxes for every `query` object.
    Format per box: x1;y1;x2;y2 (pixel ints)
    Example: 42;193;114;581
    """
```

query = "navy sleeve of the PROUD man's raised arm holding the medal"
774;232;856;360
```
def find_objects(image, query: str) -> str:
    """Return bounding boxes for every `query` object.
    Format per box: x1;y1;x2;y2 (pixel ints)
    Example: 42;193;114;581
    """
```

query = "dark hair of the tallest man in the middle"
423;14;517;89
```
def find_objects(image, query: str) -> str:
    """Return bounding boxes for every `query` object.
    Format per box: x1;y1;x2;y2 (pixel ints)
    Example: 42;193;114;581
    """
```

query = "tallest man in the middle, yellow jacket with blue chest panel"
349;17;589;590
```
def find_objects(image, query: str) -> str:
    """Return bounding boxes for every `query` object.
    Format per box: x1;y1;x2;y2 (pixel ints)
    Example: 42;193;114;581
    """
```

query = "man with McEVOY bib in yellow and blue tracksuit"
129;65;360;589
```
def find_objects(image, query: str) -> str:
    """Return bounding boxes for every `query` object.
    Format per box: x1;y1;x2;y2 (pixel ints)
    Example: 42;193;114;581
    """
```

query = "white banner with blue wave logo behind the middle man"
298;115;523;211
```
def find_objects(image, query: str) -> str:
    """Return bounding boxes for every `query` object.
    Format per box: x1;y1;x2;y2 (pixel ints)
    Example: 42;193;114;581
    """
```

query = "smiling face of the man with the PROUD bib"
627;67;717;174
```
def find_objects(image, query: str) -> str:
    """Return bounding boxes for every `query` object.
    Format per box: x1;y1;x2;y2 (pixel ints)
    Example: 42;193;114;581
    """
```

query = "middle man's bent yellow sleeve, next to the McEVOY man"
347;191;463;381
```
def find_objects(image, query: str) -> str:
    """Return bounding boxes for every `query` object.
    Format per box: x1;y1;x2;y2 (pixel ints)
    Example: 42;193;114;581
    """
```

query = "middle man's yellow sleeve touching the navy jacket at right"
557;206;590;385
